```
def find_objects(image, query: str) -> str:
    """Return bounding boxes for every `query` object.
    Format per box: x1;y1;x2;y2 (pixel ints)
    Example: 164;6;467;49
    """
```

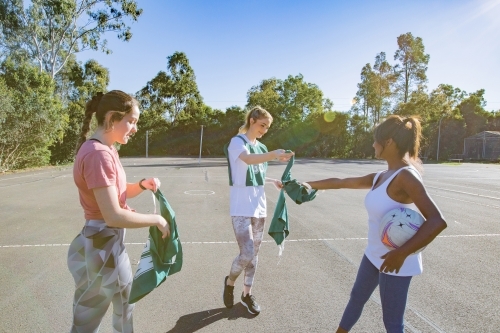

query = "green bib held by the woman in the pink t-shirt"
129;189;182;303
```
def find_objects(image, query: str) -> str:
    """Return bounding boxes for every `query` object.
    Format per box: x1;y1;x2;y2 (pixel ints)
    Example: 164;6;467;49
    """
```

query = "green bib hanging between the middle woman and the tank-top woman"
268;154;318;245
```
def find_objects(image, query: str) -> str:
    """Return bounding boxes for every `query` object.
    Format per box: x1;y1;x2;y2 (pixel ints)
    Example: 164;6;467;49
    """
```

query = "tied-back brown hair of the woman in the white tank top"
373;115;422;160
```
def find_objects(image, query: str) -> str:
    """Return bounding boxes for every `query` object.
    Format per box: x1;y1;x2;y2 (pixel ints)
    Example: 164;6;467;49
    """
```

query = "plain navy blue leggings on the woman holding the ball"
339;256;412;333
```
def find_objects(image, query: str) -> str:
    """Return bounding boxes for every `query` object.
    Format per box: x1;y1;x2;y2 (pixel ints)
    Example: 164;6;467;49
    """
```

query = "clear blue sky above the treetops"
77;0;500;111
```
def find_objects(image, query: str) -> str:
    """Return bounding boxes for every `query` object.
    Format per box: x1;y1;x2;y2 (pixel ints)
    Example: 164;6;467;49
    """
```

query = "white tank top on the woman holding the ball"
365;166;423;276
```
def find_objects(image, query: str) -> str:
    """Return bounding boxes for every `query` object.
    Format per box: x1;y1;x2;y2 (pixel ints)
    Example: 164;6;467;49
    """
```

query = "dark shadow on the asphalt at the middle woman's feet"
166;303;255;333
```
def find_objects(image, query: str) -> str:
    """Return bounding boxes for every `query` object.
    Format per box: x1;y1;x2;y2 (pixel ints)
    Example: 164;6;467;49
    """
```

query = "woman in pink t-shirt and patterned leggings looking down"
68;90;169;333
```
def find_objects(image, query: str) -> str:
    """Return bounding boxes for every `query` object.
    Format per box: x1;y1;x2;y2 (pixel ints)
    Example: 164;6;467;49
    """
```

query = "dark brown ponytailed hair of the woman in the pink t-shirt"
76;90;139;153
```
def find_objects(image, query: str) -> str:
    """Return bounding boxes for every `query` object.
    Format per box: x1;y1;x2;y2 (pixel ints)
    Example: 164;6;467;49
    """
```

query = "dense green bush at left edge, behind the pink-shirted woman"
0;60;68;171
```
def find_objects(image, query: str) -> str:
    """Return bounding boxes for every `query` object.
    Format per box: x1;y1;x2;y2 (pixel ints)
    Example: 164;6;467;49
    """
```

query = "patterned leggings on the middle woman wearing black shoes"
229;216;266;287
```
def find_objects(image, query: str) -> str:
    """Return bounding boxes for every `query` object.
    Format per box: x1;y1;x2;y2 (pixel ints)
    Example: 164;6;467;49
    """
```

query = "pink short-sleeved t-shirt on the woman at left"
73;140;132;220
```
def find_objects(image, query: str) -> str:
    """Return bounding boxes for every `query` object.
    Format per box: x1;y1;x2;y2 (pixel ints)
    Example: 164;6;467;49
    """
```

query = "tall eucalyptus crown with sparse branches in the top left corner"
0;0;142;79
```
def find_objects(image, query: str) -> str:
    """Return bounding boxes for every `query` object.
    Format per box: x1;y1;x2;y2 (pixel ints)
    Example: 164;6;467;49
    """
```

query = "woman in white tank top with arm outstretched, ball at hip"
307;115;446;333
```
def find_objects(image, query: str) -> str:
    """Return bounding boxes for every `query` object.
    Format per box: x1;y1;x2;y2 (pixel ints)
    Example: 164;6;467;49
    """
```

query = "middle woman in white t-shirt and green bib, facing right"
223;106;294;314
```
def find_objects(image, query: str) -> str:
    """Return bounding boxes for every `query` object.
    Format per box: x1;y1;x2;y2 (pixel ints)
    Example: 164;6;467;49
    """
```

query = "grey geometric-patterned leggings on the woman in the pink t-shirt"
68;220;134;333
